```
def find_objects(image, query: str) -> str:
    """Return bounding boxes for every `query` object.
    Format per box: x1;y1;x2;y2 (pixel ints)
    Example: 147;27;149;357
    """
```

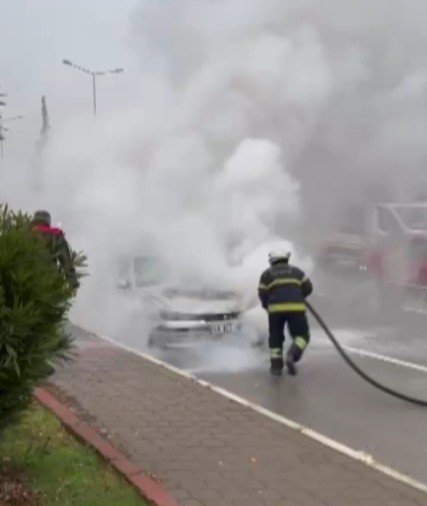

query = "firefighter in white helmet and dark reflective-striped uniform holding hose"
258;251;313;376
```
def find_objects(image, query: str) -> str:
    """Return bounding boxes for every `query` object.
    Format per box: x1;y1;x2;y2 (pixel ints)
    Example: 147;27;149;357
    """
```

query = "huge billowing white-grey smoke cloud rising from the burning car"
2;0;427;342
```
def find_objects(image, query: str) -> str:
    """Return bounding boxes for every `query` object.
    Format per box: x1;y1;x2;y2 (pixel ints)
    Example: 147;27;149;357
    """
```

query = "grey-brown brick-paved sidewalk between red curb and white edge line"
50;324;427;506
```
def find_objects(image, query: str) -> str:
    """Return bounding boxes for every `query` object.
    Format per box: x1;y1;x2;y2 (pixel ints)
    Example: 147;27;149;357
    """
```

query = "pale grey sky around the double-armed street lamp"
0;0;137;153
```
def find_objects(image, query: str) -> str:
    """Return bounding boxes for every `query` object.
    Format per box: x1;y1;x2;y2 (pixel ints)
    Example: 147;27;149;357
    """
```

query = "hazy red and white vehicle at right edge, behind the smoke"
318;203;427;312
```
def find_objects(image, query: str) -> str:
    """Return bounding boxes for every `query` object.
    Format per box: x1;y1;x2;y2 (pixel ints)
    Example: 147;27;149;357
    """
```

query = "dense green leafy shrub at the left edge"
0;205;85;428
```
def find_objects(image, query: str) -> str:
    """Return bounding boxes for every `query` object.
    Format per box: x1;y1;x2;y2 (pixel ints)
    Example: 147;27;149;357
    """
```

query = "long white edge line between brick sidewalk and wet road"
79;331;427;494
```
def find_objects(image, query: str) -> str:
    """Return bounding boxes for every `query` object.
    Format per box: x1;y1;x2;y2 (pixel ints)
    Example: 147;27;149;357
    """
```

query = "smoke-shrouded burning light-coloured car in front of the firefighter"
116;255;242;347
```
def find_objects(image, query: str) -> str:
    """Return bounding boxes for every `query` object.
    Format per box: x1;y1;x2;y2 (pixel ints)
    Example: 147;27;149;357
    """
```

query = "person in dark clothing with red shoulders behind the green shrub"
32;210;79;290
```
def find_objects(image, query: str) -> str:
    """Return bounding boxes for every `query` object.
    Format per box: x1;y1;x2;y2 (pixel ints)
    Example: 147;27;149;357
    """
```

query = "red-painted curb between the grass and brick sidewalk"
34;388;179;506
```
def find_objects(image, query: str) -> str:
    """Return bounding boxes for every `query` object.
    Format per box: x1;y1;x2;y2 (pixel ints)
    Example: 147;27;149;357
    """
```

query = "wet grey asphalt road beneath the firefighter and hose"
151;317;427;483
